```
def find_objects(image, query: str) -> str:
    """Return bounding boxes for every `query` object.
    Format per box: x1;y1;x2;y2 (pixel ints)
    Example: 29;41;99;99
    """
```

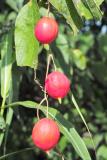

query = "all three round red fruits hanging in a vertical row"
32;13;70;151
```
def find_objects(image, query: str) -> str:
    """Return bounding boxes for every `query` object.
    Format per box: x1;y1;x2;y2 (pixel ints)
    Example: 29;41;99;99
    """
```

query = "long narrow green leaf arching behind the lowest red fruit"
6;101;91;160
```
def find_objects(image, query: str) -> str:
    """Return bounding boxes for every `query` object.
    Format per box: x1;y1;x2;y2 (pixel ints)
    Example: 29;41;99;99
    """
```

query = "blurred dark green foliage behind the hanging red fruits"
0;0;107;160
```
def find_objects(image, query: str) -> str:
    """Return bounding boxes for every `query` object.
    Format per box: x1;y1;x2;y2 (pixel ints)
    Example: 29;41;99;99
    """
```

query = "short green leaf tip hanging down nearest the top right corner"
82;0;103;20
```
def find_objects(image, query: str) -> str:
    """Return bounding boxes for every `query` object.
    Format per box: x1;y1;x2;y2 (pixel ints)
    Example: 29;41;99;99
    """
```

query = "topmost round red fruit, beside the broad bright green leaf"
34;17;58;44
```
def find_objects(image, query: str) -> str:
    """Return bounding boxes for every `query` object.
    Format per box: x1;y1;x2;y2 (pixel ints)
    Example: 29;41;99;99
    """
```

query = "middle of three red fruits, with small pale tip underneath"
45;71;70;99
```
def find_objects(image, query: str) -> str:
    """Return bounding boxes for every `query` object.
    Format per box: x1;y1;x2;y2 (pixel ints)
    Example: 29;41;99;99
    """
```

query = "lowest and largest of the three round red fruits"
32;118;60;151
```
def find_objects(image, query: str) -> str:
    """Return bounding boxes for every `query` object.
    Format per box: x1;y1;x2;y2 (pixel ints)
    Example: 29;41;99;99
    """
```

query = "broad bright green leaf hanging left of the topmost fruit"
15;0;39;67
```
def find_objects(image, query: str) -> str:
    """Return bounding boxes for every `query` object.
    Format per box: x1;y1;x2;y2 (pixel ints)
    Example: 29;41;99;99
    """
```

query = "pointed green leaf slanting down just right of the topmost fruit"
49;0;78;34
